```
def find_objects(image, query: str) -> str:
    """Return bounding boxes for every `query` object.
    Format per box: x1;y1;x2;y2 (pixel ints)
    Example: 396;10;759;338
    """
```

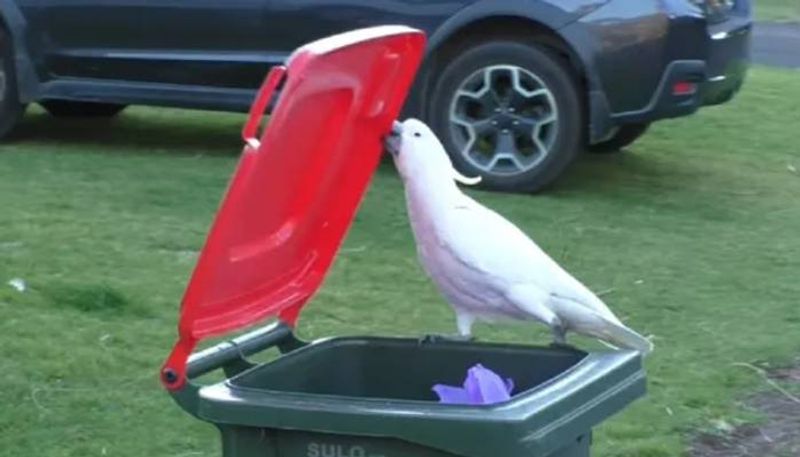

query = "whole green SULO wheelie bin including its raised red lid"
160;26;646;457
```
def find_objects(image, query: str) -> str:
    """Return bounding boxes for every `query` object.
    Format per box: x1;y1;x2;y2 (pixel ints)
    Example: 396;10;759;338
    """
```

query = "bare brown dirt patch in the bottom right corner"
690;360;800;457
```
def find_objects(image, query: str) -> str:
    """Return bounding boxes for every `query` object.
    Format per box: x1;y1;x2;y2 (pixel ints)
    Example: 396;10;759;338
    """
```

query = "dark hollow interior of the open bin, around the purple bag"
230;338;586;401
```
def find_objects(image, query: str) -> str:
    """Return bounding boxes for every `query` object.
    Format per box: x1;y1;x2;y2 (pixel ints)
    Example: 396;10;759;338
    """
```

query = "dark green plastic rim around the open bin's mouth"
195;337;646;457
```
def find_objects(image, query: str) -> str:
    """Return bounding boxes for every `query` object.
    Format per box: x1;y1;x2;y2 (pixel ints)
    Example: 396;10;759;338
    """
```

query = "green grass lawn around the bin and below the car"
0;65;800;457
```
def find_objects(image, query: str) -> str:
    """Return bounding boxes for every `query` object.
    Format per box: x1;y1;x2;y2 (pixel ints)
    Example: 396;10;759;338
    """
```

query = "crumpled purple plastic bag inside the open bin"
433;364;514;405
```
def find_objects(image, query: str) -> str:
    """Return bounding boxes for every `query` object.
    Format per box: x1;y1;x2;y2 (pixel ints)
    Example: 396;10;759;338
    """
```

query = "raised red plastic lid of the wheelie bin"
159;26;425;388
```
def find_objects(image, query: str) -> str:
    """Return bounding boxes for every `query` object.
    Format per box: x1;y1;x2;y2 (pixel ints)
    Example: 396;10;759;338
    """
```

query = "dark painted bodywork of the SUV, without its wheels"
0;0;752;142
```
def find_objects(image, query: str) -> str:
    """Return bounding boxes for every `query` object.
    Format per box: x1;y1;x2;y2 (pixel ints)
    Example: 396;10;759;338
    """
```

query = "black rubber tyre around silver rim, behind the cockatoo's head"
427;38;585;192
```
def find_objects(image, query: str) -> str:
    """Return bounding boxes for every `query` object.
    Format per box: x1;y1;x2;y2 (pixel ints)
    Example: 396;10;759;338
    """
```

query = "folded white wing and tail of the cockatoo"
437;197;653;354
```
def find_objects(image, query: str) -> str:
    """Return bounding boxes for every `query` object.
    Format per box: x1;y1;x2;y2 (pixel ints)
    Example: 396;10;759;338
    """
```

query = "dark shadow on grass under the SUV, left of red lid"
13;108;245;155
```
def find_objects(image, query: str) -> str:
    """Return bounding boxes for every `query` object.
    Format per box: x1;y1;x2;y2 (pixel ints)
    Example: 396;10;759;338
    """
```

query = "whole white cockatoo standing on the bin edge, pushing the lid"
386;119;653;354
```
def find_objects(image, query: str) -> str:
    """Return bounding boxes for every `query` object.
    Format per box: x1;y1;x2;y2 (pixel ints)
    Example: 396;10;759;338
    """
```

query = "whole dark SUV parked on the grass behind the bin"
0;0;752;191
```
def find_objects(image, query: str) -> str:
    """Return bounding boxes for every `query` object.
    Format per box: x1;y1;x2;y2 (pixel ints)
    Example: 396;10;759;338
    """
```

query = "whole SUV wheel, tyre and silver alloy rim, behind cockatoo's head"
428;39;584;192
